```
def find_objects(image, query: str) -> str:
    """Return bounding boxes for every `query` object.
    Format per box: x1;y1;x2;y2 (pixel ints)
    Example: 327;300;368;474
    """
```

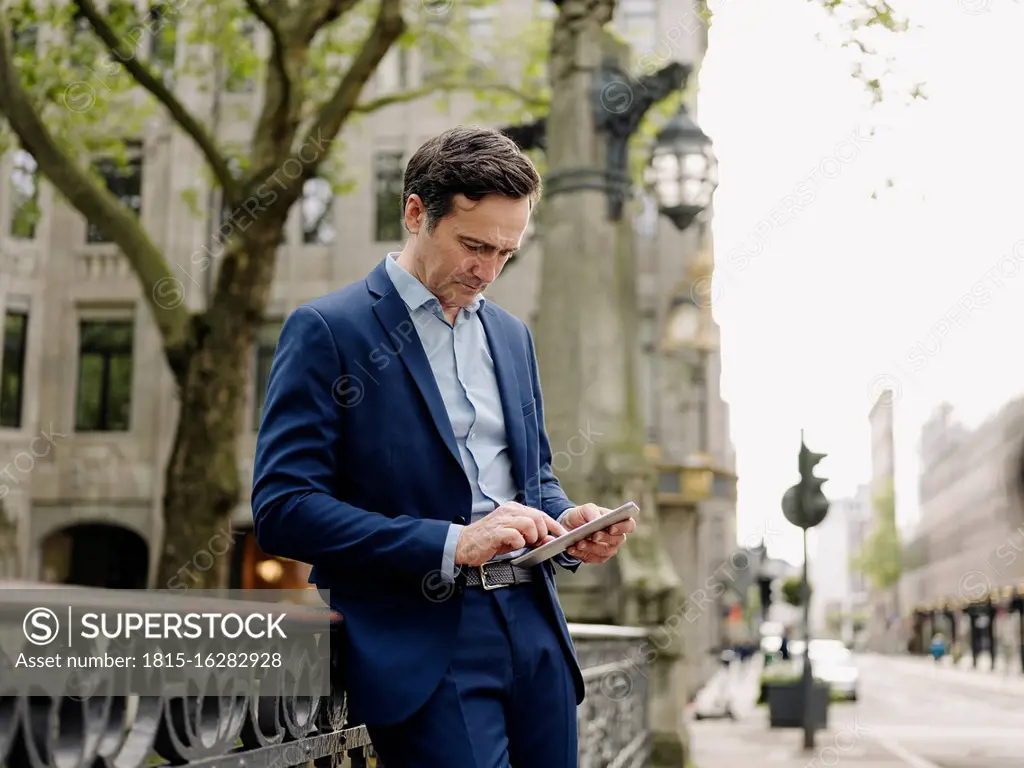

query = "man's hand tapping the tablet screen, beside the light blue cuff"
455;502;565;565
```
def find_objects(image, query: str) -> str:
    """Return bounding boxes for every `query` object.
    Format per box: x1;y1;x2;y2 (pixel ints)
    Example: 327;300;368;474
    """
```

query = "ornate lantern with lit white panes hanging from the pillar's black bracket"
645;104;718;231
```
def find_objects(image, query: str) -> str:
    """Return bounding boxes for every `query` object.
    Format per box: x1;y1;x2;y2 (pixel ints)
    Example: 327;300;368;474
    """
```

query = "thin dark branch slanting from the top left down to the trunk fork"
75;0;241;203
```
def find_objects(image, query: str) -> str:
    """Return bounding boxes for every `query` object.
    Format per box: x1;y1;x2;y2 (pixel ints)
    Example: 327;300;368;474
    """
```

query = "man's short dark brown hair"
401;126;541;232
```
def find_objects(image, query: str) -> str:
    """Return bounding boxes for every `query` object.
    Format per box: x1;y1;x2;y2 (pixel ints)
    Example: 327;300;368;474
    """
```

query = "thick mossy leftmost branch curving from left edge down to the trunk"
0;15;191;373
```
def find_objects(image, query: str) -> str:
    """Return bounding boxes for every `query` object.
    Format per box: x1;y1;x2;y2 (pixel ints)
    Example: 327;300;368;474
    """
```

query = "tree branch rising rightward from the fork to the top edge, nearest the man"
293;0;406;184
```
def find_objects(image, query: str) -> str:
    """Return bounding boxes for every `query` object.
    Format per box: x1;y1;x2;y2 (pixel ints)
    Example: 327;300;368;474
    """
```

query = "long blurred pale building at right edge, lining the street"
900;397;1024;669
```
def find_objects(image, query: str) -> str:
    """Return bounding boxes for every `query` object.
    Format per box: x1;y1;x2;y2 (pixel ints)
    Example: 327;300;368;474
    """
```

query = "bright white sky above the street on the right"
698;0;1024;562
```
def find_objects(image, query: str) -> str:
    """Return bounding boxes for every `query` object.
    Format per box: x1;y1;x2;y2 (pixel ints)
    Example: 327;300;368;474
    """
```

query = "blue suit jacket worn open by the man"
252;261;584;725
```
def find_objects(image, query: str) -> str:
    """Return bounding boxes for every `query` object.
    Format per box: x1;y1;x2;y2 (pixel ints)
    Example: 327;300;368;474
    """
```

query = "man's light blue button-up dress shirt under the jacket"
385;253;579;581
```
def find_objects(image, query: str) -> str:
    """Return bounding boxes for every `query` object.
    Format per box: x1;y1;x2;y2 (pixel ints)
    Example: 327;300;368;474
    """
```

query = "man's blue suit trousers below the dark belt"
368;583;578;768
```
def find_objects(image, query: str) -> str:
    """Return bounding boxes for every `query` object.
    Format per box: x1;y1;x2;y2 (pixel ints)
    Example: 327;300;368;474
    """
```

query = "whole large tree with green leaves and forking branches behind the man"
0;0;543;588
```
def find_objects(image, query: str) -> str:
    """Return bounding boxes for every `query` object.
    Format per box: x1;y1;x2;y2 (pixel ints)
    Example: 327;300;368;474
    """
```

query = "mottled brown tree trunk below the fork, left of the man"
157;231;282;589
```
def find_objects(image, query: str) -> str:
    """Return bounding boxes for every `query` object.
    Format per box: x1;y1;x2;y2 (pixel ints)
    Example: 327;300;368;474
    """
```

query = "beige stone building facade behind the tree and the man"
0;0;735;642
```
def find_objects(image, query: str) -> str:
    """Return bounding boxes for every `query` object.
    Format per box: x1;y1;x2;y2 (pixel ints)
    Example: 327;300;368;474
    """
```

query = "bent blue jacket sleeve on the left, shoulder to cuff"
252;306;450;575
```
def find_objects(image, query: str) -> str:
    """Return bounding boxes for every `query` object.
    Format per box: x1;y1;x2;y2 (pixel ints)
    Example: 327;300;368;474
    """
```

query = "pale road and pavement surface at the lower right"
692;656;1024;768
